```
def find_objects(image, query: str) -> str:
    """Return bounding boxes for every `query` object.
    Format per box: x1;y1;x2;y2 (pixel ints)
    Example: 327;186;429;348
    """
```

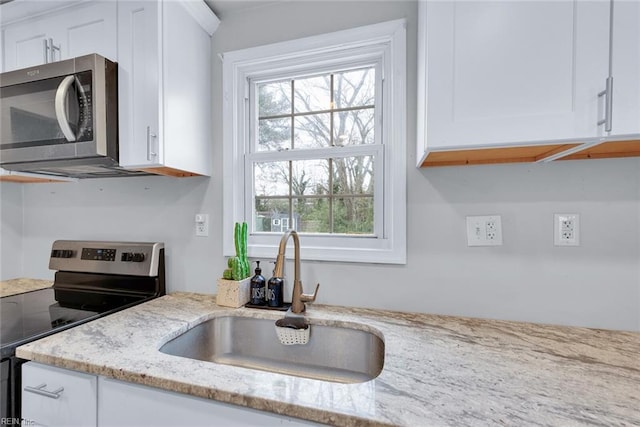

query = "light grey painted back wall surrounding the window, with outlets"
2;1;640;330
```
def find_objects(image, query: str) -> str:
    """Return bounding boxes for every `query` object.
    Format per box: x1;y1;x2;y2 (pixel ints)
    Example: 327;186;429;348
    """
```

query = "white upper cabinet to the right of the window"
418;0;640;165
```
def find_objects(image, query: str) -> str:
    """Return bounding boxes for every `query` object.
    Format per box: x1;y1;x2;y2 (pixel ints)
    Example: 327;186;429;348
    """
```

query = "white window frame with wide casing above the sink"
222;19;407;264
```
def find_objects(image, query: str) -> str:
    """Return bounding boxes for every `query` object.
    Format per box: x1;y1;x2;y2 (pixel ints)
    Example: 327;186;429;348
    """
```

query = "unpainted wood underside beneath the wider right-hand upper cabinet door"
421;144;580;168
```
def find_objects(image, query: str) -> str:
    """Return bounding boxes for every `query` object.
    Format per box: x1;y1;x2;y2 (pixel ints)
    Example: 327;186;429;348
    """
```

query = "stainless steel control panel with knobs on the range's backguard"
49;240;164;276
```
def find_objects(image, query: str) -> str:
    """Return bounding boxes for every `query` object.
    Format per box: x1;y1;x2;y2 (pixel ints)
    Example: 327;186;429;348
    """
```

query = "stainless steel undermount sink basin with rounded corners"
160;316;384;383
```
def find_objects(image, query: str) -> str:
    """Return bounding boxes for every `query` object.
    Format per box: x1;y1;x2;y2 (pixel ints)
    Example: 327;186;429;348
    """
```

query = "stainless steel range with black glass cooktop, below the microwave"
0;240;165;419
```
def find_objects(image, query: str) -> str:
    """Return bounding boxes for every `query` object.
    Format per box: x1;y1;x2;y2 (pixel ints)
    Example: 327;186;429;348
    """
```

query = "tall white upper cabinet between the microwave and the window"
118;1;219;176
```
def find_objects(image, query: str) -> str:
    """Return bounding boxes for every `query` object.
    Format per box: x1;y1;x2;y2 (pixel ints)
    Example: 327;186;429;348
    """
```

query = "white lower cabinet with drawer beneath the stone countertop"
22;362;321;427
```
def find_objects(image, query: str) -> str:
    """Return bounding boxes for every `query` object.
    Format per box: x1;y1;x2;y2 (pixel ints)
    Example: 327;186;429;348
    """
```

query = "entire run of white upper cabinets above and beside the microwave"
0;0;220;181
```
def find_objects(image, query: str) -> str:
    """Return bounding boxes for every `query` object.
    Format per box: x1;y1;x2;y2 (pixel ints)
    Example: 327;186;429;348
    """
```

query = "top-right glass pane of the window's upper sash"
333;68;376;108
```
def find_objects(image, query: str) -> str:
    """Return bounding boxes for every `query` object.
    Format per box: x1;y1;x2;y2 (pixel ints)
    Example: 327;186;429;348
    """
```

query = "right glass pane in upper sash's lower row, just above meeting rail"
333;108;375;147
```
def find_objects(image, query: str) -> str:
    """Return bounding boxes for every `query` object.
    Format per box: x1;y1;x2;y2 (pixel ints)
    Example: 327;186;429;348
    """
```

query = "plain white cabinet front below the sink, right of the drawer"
98;377;320;427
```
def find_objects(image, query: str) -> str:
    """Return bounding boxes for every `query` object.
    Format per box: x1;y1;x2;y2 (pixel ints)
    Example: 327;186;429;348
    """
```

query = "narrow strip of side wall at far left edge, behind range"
0;183;23;280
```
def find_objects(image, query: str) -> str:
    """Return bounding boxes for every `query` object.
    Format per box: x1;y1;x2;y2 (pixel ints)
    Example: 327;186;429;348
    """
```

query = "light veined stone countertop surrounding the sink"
17;293;640;426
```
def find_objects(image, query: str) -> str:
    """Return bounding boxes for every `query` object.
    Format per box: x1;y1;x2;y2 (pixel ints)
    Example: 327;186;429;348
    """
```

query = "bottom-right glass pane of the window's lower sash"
333;197;373;234
